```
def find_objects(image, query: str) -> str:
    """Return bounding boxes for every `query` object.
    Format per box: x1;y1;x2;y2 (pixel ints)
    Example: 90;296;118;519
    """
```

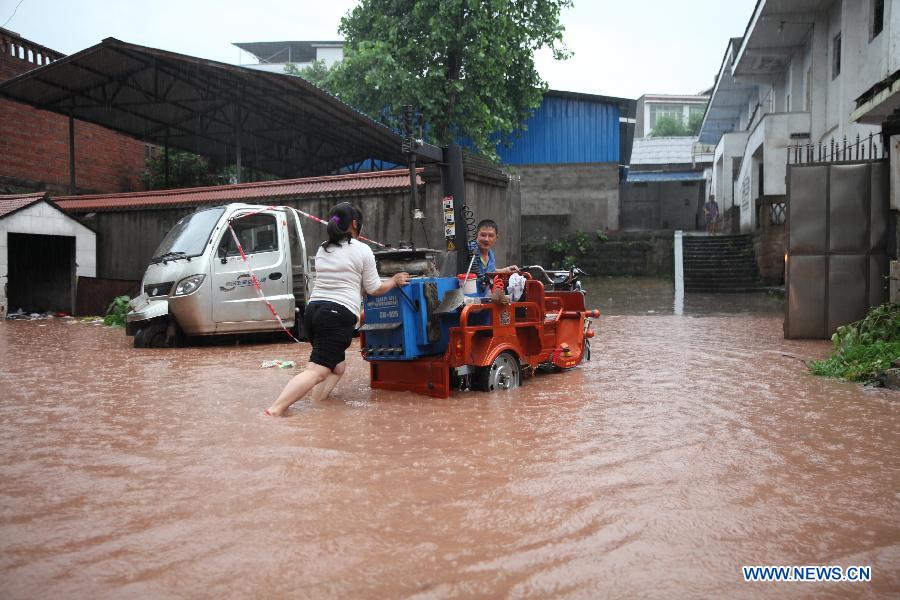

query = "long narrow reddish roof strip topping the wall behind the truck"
54;169;422;213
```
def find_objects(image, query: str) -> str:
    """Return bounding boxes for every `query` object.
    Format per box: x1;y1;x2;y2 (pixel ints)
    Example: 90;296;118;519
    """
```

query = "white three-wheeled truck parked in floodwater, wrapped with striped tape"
125;204;313;348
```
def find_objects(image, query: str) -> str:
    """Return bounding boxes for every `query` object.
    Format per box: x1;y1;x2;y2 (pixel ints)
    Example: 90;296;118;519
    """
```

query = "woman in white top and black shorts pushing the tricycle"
264;202;409;417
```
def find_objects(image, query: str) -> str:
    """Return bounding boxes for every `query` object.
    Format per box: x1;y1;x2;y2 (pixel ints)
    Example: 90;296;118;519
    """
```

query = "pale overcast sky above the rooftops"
0;0;756;98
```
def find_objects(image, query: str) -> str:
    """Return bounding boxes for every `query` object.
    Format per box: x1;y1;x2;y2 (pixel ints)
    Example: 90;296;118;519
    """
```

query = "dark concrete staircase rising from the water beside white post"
682;235;765;293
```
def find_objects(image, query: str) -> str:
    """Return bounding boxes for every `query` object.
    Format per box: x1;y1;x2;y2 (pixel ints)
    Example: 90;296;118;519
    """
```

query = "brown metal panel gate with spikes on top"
784;137;889;339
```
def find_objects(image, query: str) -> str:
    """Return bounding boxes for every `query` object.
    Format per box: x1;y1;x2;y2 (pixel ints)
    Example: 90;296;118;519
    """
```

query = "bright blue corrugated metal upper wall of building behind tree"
498;90;635;165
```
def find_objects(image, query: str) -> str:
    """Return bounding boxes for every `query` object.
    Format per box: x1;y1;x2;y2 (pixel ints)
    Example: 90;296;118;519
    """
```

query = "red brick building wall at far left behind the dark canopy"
0;30;145;193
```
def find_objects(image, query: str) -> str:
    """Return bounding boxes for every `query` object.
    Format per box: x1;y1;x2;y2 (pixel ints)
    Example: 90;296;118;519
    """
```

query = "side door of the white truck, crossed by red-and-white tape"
212;211;294;333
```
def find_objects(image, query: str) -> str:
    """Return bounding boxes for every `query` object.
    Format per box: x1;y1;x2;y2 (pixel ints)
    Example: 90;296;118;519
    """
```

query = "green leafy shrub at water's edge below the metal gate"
809;304;900;381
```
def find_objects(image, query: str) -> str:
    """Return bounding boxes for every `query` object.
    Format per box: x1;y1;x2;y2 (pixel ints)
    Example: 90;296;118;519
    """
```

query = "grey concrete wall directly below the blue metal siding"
507;163;619;240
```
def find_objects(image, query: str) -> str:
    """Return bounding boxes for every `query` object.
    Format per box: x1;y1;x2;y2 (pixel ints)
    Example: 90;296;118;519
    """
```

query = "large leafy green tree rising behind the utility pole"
325;0;572;156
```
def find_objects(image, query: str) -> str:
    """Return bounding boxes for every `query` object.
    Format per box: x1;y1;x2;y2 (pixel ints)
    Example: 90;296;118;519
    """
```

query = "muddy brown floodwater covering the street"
0;280;900;598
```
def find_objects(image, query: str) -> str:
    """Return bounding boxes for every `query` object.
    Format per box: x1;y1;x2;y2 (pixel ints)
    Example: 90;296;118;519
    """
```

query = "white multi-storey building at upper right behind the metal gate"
700;0;888;232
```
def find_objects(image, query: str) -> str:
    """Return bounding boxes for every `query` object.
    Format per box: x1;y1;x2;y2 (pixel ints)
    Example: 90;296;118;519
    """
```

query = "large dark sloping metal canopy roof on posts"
0;38;414;177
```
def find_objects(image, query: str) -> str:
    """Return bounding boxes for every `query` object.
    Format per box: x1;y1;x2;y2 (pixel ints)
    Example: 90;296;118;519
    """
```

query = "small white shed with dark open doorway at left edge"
0;192;97;318
